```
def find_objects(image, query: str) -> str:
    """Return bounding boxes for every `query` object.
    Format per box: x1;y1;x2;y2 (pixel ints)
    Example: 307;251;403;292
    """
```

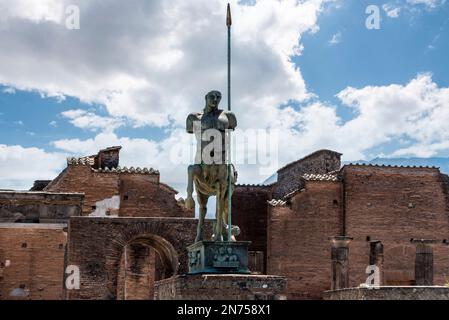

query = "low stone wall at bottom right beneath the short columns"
323;286;449;300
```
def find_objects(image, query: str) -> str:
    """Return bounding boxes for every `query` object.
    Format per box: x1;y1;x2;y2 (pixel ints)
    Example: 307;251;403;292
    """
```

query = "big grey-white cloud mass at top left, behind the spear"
0;0;332;126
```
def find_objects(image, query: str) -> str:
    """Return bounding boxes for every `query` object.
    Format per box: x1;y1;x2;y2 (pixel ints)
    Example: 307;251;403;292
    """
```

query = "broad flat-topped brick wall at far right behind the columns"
343;166;449;286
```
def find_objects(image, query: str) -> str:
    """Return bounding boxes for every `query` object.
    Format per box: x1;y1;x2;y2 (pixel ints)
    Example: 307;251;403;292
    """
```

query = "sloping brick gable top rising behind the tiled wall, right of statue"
273;150;341;199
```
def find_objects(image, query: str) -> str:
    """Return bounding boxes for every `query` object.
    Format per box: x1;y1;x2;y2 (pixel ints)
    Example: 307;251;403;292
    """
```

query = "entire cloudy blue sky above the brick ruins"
0;0;449;189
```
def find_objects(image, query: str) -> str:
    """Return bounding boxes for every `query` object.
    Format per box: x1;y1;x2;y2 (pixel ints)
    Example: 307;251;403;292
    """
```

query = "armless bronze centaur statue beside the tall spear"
186;91;239;242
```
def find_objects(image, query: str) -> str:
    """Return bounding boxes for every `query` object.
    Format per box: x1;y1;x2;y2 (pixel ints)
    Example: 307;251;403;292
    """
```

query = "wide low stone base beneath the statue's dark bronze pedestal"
154;274;287;300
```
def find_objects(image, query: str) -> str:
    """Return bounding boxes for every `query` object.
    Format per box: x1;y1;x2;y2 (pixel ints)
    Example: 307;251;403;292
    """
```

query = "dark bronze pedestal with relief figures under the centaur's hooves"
187;241;251;274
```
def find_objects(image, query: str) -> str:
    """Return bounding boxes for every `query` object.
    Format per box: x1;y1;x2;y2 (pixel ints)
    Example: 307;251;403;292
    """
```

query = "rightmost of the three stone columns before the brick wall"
410;239;436;286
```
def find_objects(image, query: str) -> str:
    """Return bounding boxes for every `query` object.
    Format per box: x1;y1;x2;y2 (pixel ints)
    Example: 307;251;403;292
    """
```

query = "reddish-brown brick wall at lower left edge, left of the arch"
0;224;67;300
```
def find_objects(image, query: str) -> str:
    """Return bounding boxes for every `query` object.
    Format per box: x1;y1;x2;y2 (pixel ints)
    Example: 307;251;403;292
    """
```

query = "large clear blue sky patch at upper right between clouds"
294;0;449;102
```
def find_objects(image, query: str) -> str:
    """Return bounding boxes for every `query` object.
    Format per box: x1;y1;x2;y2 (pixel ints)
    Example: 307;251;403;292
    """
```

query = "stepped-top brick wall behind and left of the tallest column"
267;181;342;299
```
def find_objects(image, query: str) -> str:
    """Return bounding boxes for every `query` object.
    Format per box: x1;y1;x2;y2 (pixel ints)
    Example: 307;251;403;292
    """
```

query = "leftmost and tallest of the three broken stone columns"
329;236;353;290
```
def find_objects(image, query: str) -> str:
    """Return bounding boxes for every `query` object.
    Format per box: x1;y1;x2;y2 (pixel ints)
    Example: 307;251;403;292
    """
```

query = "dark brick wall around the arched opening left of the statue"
66;217;197;299
